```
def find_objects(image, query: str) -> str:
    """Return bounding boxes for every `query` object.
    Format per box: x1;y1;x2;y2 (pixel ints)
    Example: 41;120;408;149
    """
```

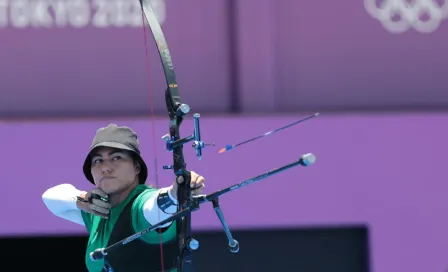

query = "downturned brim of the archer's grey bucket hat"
82;142;148;185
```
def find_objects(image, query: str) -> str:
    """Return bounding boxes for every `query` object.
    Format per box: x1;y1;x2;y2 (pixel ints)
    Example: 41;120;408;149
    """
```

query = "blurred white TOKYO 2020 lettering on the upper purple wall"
0;0;166;28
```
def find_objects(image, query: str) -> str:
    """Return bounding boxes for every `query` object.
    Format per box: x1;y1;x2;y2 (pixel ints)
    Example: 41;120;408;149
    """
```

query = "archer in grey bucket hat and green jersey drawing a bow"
42;124;205;272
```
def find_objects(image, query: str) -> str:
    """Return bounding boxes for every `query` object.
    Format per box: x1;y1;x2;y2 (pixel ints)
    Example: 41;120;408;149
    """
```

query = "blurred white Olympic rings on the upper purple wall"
364;0;448;34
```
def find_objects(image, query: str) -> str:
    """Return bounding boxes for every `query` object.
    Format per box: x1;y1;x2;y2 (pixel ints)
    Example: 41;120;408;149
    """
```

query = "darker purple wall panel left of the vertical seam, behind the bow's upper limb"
0;0;230;116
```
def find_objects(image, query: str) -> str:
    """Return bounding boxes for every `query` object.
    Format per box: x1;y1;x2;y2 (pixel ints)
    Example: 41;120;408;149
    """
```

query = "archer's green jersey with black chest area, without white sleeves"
82;185;178;272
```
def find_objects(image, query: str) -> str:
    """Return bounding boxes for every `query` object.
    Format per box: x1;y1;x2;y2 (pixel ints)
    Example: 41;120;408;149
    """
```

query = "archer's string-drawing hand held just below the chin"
76;188;111;219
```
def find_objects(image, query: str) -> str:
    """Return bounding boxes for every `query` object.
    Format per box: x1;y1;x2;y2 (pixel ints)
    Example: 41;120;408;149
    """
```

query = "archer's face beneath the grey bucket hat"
91;148;139;195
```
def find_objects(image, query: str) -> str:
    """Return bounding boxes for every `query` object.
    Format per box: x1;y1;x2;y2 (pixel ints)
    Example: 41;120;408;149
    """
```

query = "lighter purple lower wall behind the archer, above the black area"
0;114;448;272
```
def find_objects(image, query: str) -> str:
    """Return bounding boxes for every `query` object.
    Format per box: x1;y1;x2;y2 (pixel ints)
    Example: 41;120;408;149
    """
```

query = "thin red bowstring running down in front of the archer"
142;6;165;272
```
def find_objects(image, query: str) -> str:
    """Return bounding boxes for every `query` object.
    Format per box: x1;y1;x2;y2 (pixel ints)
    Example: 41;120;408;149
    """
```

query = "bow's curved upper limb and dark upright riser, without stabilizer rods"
139;0;192;272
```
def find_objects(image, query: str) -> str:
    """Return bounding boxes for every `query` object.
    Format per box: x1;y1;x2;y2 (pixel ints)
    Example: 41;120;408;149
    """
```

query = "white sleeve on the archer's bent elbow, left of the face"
42;184;84;225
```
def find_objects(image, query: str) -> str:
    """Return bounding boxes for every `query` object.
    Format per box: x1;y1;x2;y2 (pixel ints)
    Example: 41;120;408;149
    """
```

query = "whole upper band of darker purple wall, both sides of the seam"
0;0;448;116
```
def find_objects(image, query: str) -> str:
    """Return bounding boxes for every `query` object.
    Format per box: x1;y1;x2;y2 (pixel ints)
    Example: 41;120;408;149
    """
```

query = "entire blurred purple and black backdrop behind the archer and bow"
0;0;448;272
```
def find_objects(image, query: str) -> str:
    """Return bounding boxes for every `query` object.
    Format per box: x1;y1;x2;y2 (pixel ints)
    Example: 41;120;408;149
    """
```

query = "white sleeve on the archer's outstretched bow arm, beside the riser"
143;188;178;228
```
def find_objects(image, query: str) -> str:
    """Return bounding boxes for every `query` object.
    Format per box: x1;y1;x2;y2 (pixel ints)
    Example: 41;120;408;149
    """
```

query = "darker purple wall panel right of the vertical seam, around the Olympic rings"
238;0;448;111
